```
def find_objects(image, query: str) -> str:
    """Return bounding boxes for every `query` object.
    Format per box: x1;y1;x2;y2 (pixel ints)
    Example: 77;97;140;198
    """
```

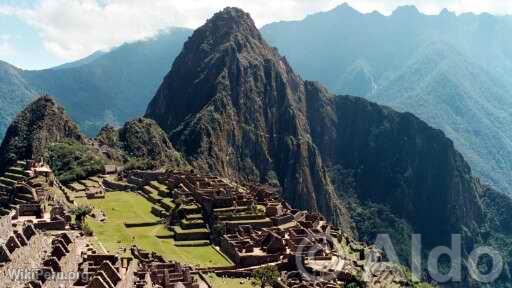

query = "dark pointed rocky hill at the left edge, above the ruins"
0;96;86;169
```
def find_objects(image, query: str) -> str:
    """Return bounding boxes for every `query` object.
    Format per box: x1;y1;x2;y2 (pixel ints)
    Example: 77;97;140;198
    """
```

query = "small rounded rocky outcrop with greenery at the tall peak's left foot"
96;118;188;168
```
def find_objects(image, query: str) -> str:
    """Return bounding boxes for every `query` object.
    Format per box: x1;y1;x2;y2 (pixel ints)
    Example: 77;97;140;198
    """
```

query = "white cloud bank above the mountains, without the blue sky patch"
0;0;512;60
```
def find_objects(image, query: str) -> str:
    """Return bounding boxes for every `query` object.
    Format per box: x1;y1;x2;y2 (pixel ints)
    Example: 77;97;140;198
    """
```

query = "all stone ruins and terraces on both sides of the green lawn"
0;158;416;288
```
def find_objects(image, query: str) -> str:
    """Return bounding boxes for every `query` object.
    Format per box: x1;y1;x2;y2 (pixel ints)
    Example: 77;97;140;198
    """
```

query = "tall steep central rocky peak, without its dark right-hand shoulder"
146;8;347;227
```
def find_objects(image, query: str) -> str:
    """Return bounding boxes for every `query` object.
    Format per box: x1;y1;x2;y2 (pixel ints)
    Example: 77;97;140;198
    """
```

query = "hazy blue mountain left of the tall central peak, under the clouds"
0;28;190;138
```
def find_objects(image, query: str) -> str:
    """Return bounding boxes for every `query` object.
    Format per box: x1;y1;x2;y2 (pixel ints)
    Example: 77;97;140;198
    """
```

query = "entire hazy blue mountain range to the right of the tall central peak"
262;4;512;192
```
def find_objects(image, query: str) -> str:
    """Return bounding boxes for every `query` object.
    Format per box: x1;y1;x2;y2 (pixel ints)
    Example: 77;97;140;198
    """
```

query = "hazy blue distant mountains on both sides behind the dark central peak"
0;4;512;198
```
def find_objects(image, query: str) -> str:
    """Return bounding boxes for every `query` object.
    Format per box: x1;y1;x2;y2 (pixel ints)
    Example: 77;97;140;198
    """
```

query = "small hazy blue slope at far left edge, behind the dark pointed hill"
0;61;36;139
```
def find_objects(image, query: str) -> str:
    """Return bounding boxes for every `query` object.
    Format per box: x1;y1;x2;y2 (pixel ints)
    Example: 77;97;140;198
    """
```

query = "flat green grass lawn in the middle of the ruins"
80;192;232;267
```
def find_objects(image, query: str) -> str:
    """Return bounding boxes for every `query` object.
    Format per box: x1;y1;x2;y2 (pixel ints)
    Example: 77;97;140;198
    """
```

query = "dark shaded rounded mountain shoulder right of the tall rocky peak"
306;82;484;245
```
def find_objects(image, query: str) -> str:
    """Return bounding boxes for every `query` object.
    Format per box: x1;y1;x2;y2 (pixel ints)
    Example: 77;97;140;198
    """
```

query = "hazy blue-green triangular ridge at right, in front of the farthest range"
374;43;512;196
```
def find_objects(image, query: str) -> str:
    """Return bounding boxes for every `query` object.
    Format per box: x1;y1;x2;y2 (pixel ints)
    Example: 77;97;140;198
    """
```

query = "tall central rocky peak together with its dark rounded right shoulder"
146;8;484;250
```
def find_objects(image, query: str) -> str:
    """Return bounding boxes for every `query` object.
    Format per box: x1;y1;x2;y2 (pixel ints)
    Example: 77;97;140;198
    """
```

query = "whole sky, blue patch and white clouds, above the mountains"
0;0;512;70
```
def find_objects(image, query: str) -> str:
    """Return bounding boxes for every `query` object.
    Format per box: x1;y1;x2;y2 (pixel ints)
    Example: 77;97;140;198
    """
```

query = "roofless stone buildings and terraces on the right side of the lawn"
113;170;408;287
